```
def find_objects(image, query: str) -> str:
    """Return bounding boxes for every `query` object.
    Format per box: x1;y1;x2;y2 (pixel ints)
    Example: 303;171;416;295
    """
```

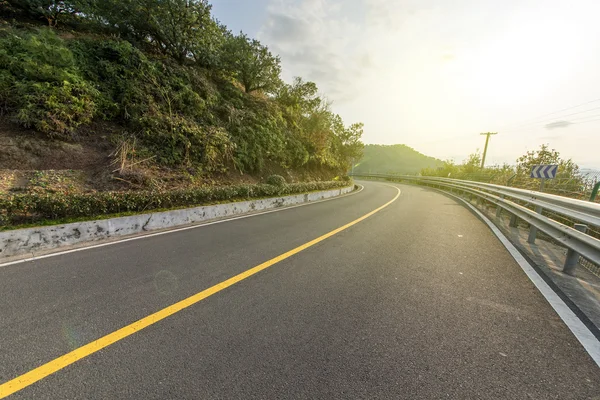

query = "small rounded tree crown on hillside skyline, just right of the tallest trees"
223;32;281;93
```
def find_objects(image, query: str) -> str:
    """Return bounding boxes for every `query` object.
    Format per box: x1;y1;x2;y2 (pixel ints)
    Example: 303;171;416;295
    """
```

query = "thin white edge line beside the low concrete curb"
0;183;365;268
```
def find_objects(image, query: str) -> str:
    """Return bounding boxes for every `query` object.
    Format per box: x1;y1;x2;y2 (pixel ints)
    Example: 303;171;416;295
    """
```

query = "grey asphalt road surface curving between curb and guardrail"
0;182;600;399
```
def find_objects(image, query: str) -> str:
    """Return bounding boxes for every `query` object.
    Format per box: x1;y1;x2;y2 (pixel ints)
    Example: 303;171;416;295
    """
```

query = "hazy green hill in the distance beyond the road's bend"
354;144;444;174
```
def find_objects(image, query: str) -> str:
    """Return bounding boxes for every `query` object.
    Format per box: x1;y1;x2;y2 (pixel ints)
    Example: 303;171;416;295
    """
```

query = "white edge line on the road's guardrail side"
443;192;600;367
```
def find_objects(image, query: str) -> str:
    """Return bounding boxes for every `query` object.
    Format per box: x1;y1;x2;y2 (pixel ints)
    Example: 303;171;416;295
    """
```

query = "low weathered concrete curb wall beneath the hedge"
0;185;354;260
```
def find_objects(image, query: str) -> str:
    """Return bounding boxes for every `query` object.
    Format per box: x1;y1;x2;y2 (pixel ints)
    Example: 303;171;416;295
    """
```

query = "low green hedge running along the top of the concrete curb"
0;181;348;226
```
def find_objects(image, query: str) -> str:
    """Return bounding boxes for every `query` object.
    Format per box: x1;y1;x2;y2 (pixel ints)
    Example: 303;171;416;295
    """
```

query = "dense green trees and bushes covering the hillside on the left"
0;0;363;177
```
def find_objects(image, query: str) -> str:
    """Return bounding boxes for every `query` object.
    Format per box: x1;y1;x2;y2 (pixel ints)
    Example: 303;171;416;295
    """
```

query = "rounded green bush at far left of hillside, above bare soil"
0;29;98;138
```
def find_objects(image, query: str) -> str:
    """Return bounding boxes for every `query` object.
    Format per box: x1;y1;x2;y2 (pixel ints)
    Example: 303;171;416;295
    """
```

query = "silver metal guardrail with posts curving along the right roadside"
354;174;600;275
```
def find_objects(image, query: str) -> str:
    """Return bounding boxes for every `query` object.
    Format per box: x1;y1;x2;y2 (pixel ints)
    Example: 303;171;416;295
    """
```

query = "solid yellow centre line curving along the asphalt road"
0;185;400;399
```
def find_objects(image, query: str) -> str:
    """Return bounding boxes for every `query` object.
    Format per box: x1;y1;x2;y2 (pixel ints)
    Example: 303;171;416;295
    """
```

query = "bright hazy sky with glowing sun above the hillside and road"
211;0;600;169
